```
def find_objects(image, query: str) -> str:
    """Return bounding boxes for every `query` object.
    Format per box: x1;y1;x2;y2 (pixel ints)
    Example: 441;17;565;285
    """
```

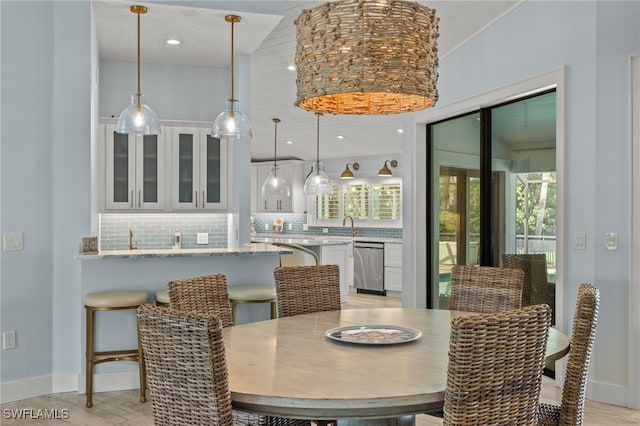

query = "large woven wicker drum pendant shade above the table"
295;0;438;114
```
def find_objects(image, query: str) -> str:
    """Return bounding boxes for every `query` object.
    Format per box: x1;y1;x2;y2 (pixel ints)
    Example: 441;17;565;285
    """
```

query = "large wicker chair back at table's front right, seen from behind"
443;305;551;426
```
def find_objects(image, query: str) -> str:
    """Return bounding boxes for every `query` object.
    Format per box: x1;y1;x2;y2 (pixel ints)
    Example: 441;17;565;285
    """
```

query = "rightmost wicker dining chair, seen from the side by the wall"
538;283;600;426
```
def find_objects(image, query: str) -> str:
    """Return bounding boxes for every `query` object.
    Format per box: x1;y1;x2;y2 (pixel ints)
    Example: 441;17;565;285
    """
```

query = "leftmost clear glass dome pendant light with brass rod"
116;5;161;135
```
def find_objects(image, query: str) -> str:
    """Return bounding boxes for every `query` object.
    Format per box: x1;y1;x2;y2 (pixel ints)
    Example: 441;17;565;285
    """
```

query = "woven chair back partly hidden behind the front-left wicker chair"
168;274;233;327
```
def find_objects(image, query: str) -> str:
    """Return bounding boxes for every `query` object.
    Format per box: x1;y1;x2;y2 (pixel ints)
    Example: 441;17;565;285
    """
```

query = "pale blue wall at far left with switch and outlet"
0;1;91;394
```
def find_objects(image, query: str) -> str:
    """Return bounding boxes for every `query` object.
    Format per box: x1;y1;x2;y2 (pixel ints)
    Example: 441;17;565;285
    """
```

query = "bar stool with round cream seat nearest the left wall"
84;291;148;408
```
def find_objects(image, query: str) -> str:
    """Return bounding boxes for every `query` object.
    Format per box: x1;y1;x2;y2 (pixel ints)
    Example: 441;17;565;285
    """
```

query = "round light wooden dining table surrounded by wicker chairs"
223;308;569;424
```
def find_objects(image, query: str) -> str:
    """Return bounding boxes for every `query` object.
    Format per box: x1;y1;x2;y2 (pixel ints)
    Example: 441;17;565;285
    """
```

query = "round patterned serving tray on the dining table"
325;325;422;345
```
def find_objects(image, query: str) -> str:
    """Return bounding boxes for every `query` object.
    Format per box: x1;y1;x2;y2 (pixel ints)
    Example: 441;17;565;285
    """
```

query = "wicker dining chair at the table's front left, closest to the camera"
137;304;311;426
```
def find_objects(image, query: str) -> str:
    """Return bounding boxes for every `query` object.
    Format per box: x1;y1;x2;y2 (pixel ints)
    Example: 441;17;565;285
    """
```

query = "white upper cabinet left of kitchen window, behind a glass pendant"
251;160;306;213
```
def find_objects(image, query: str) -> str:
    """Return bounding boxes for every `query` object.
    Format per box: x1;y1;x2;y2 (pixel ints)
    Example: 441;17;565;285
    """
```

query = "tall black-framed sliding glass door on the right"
426;91;556;320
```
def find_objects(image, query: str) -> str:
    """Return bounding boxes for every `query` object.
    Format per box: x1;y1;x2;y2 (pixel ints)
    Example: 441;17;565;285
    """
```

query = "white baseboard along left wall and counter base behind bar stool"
0;370;140;404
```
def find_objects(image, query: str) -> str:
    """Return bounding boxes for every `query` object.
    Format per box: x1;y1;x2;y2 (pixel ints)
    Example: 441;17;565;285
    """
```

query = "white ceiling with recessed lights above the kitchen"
93;0;548;161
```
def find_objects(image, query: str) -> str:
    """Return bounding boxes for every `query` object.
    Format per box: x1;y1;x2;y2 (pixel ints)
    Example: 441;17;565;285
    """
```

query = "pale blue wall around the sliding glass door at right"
405;1;640;405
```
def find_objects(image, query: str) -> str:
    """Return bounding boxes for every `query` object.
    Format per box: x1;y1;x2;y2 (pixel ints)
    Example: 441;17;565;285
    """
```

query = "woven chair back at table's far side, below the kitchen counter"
274;265;341;317
